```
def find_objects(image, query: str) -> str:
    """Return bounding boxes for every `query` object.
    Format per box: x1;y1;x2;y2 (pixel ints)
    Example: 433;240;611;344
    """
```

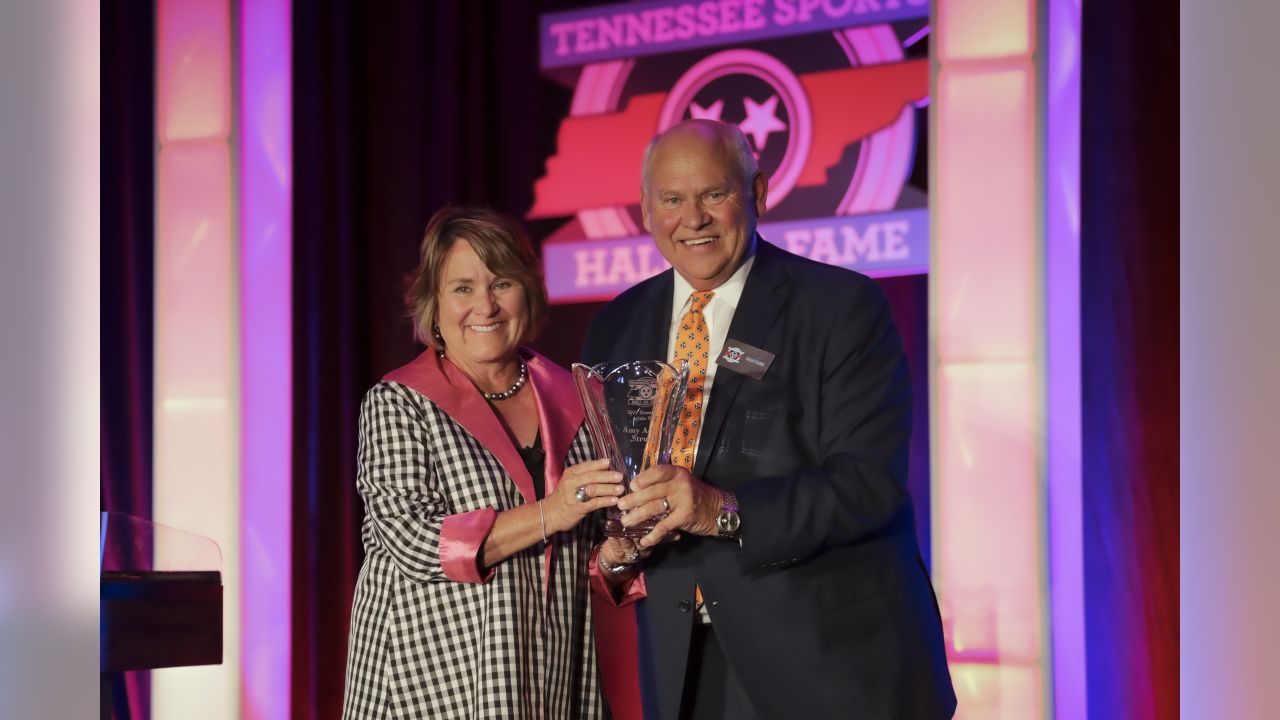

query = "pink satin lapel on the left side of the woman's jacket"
383;348;537;502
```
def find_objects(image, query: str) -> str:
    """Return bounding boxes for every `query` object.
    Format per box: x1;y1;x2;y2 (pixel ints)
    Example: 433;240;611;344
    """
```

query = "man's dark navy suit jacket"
582;237;956;720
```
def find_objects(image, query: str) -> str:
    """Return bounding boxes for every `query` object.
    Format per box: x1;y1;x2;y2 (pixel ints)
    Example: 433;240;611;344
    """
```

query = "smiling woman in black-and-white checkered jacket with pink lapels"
343;208;636;719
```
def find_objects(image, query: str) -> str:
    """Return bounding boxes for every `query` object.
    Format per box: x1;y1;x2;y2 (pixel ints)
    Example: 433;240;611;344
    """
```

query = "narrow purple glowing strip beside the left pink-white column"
237;0;293;720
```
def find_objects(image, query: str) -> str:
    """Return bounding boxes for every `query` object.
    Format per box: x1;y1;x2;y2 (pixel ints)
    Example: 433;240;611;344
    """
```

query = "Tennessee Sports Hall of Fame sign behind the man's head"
529;0;929;302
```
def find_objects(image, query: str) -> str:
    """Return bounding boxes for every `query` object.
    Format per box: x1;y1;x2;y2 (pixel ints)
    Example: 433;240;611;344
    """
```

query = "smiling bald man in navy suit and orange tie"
584;120;956;720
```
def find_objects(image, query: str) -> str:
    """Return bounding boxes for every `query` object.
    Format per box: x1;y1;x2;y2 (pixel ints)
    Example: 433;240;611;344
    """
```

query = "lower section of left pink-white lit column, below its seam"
152;141;239;717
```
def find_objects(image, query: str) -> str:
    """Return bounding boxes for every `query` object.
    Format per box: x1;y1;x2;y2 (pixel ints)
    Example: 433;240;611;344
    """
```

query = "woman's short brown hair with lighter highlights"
404;206;547;350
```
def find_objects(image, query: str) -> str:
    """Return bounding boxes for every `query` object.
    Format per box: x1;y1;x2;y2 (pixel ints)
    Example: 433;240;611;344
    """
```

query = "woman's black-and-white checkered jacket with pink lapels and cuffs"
343;351;607;719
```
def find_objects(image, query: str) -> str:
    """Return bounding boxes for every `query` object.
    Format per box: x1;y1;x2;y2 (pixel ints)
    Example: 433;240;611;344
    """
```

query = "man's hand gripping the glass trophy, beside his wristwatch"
618;465;722;547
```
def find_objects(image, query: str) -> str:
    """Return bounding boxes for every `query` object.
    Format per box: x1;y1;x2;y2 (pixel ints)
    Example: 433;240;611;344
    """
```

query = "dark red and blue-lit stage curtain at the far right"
1080;3;1177;720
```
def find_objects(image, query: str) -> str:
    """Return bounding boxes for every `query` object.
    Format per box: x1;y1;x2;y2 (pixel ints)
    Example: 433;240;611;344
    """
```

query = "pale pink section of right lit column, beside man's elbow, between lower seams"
934;363;1041;661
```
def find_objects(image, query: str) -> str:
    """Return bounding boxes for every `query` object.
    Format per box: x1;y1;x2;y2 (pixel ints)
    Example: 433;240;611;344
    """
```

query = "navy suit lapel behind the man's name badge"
696;237;788;478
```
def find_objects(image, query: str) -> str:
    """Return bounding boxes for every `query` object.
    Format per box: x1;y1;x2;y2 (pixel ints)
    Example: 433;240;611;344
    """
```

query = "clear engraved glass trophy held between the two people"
573;360;689;538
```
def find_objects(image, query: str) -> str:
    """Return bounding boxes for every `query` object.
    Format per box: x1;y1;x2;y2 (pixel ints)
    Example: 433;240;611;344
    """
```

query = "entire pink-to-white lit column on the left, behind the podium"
151;0;241;717
